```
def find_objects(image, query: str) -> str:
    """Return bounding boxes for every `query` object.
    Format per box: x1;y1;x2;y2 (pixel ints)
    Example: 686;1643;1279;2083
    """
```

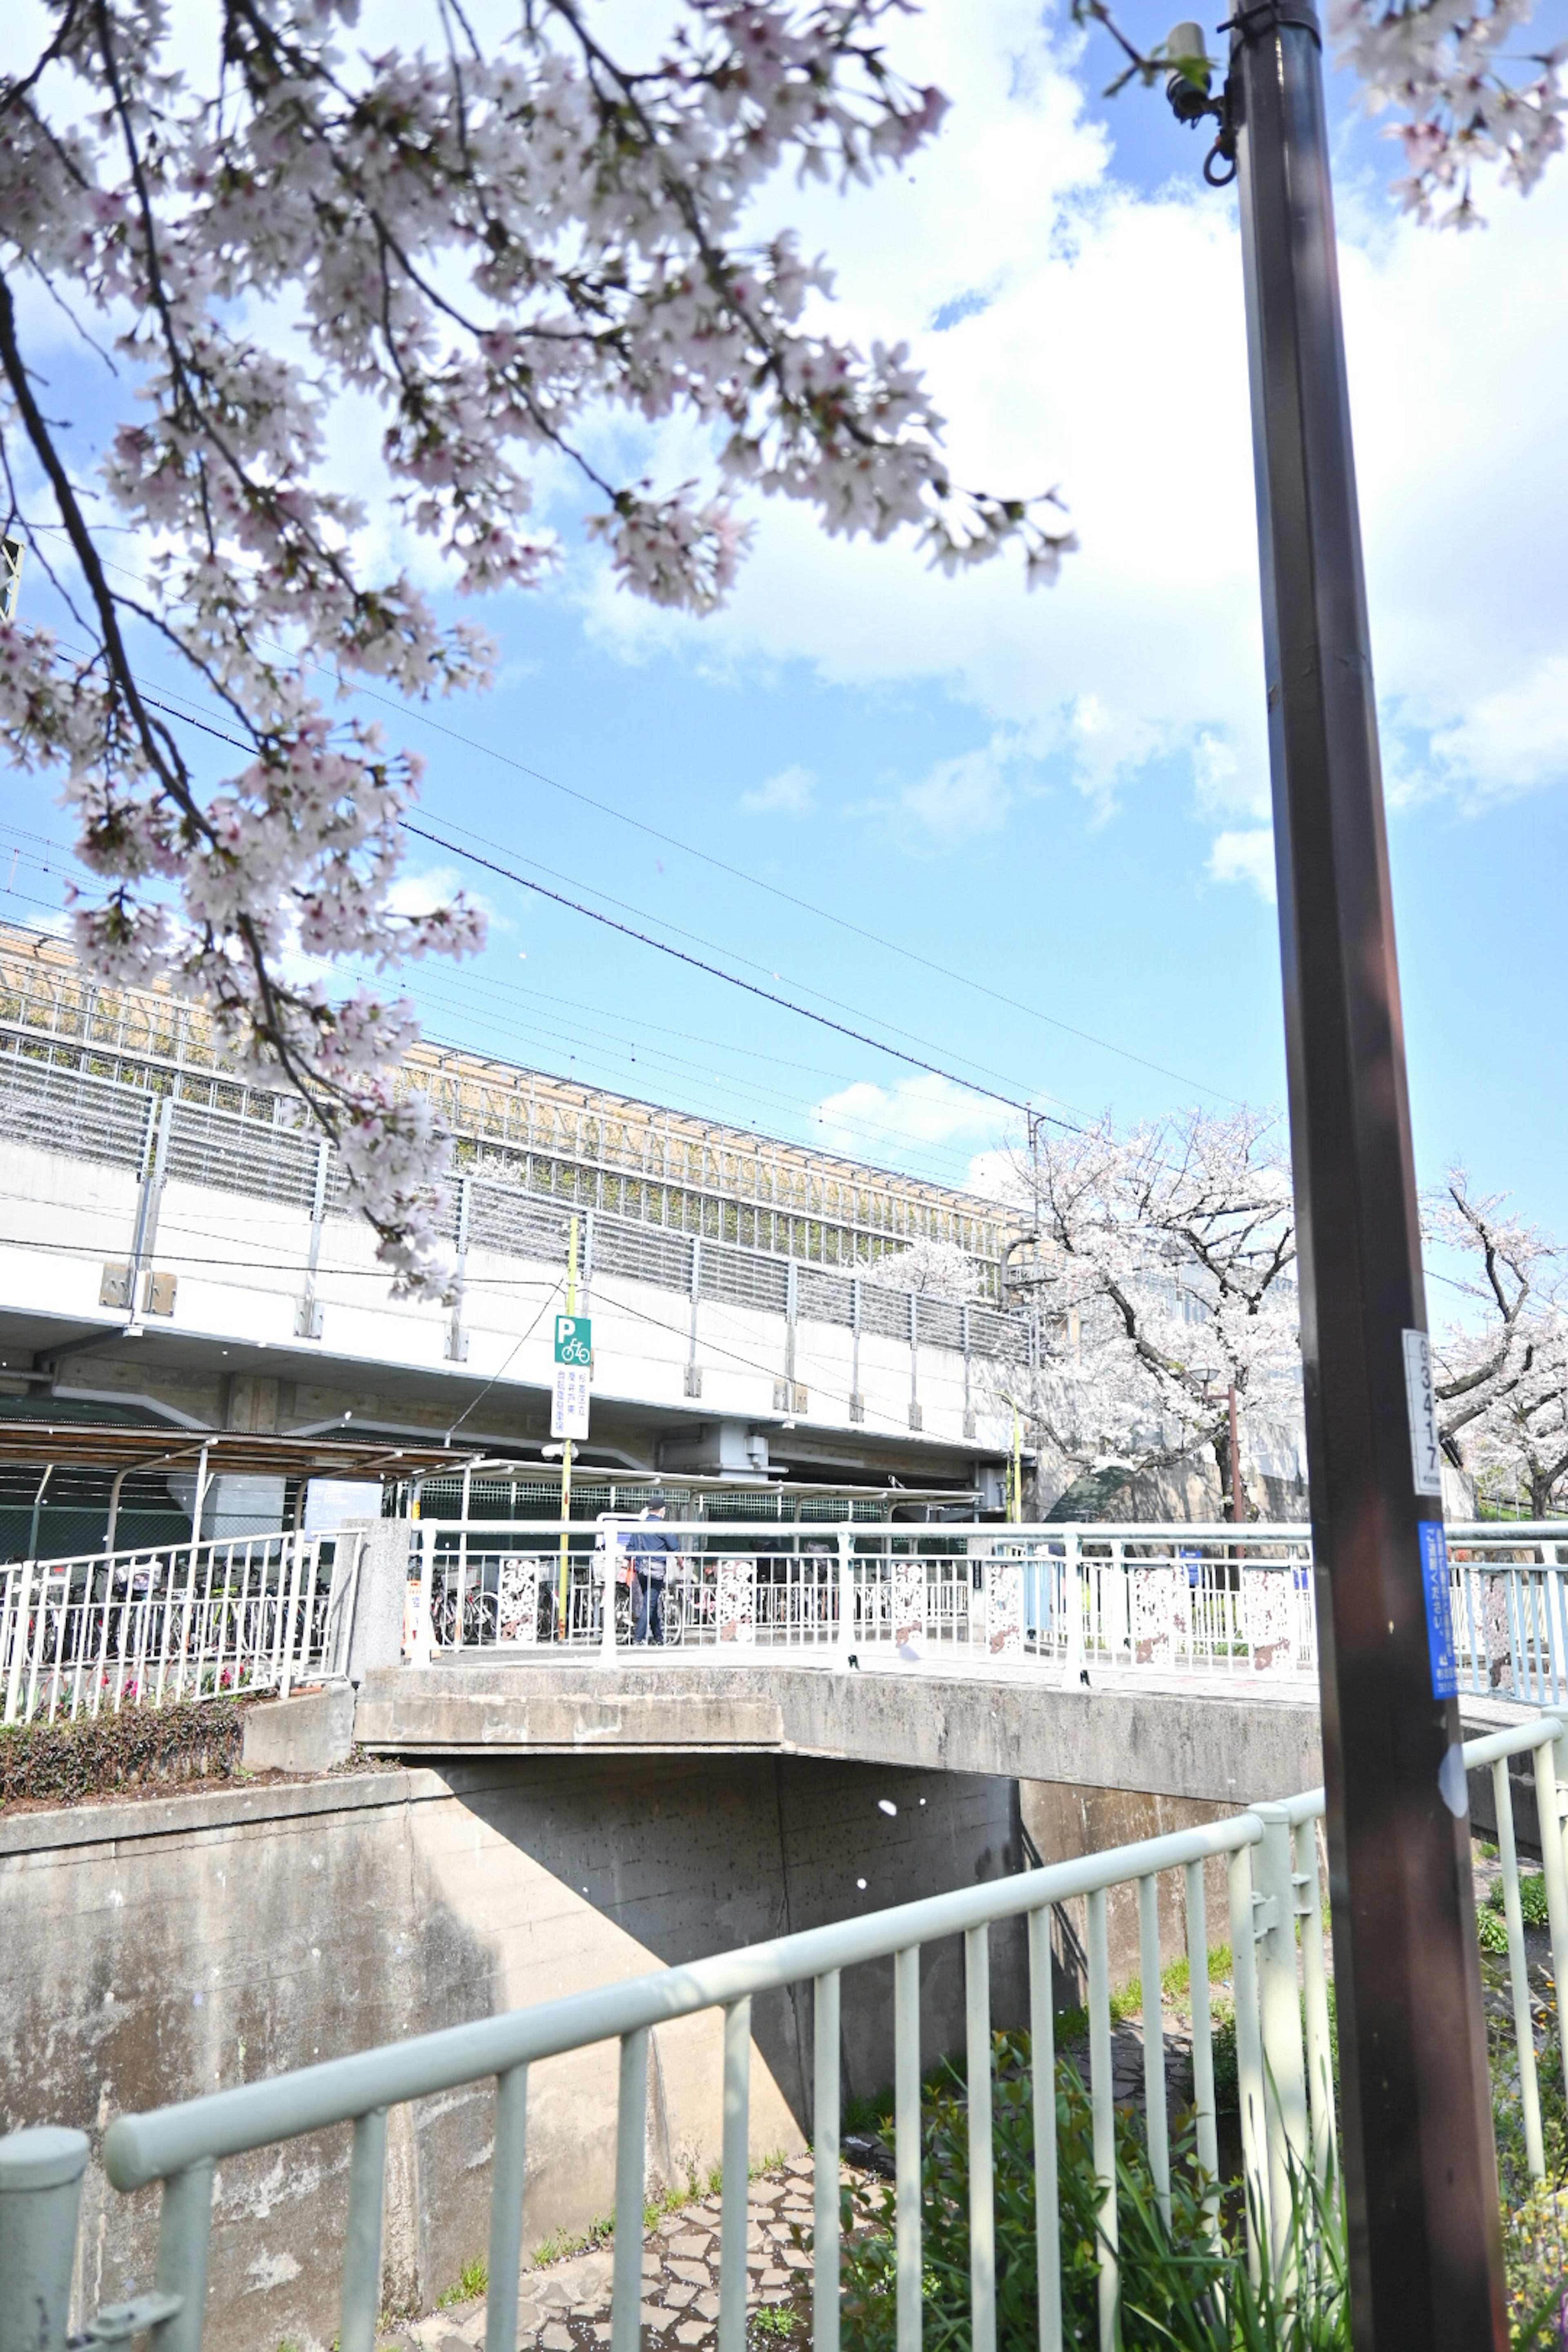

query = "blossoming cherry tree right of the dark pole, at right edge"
1425;1167;1568;1519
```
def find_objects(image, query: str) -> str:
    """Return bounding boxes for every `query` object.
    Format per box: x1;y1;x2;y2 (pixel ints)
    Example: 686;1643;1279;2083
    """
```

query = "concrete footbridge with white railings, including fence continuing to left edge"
0;1498;1568;1804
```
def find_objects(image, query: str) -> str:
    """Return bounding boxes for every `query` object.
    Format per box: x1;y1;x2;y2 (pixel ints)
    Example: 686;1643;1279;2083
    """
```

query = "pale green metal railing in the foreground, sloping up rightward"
12;1717;1568;2352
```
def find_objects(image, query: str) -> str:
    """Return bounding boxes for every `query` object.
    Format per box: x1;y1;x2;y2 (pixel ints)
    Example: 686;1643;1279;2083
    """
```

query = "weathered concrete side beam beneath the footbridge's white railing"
355;1658;1323;1804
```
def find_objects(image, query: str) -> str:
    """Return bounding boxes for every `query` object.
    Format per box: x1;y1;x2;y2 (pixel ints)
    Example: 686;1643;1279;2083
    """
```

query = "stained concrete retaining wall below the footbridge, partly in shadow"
0;1757;1025;2352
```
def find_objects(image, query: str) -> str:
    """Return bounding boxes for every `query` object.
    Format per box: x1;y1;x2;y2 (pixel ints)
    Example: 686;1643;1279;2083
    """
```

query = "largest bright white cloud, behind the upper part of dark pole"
573;0;1568;865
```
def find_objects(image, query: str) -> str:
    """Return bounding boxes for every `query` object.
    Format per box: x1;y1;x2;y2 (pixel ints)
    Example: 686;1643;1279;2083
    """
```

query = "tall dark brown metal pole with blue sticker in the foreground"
1166;23;1504;2352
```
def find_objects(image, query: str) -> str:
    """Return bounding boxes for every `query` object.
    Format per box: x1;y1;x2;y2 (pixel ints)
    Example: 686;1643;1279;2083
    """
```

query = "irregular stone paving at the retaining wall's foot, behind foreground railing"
383;2157;827;2352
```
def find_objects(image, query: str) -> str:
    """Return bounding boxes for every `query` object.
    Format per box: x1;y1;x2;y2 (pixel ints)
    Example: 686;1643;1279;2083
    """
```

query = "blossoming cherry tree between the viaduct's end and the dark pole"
1011;1110;1300;1508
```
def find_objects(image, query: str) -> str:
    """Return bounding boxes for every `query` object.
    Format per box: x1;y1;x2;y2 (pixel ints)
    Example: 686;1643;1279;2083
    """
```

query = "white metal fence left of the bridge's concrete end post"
0;1534;345;1724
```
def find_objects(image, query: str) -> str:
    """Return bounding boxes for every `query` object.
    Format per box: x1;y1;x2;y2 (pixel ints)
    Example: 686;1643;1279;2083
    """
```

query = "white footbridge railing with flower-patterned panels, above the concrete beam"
407;1519;1568;1705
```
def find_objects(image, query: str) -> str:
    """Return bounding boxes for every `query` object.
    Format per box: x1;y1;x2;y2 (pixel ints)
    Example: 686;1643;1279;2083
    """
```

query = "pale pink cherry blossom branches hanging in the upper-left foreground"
0;0;1069;1291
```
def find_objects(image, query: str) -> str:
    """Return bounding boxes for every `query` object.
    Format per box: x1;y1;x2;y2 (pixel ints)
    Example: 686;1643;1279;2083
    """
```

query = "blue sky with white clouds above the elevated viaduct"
0;0;1568;1270
